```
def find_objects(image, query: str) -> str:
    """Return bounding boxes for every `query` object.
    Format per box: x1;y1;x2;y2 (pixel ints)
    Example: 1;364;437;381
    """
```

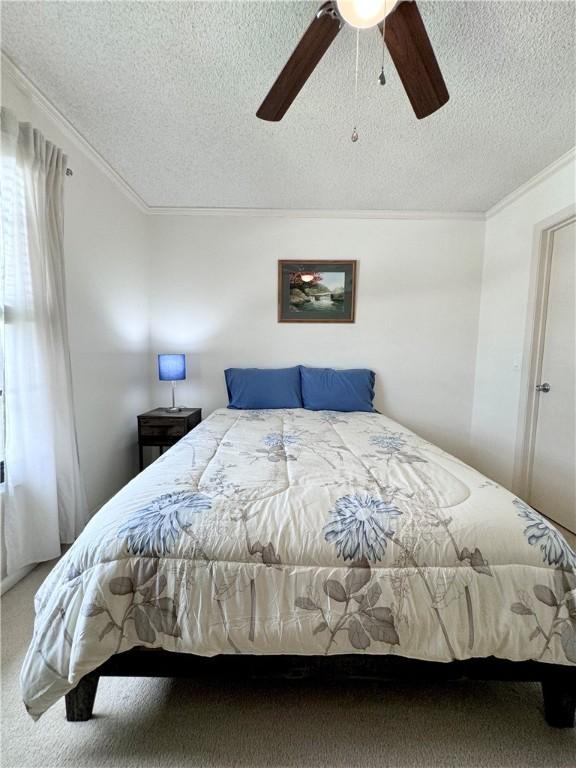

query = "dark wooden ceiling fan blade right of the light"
380;0;450;120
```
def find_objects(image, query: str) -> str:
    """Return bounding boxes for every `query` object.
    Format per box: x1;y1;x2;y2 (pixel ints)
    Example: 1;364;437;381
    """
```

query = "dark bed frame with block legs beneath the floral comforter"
66;647;576;728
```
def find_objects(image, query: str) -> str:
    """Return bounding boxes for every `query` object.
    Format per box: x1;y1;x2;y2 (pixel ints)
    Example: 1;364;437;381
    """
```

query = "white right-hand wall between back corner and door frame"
472;158;576;488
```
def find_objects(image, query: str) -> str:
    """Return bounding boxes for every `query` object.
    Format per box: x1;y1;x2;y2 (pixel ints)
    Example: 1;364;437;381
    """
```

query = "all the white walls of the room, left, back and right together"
2;55;575;536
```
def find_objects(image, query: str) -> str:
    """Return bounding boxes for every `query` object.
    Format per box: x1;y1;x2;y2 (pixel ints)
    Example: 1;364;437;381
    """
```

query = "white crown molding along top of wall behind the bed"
147;206;485;221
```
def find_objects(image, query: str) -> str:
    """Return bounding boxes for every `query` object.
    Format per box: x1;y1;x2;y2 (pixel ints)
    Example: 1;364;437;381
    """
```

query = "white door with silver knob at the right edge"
529;221;576;533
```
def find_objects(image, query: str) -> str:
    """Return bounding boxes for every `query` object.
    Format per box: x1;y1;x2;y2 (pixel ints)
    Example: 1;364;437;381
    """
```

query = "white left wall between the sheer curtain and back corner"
2;72;150;511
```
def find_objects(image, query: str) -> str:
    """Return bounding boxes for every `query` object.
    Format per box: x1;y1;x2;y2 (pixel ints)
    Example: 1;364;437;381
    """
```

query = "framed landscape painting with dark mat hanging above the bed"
278;260;356;323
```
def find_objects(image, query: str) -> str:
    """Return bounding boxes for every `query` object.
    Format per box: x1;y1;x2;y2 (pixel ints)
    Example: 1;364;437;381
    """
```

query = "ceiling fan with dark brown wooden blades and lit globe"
256;0;450;121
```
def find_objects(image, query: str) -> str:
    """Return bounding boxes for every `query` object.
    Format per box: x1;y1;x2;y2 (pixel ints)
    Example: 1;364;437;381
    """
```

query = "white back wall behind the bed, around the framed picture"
150;215;484;459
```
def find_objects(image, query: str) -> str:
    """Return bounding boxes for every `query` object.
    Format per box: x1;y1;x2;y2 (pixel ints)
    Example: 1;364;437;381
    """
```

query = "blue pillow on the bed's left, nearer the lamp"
224;365;302;409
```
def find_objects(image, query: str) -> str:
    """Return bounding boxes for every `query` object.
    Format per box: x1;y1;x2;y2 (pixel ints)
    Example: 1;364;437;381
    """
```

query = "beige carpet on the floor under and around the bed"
1;565;576;768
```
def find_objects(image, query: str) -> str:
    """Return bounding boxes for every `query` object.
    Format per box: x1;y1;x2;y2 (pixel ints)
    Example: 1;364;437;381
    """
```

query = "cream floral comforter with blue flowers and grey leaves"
22;409;576;717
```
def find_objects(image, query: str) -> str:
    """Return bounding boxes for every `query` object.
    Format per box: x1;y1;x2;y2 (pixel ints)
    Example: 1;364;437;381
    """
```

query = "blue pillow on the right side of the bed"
300;365;376;411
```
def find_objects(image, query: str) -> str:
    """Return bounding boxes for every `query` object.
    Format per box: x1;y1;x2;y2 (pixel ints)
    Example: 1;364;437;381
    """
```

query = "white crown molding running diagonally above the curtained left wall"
2;51;148;213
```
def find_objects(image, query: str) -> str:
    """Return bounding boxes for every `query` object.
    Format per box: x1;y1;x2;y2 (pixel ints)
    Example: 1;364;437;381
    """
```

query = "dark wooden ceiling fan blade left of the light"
256;0;343;121
